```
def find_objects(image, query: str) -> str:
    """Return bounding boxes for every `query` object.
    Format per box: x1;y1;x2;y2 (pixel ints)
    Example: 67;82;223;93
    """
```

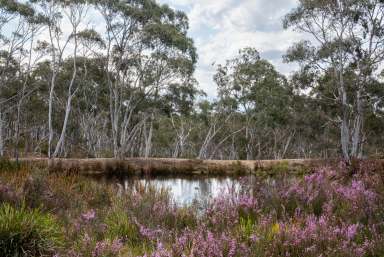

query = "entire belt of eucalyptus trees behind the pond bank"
0;0;384;161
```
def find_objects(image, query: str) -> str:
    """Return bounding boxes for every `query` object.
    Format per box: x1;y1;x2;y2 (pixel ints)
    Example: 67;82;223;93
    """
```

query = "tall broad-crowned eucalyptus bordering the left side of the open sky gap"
96;0;197;158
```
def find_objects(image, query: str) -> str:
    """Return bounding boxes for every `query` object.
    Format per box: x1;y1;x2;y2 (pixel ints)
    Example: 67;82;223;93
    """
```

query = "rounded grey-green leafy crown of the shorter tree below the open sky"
215;48;291;127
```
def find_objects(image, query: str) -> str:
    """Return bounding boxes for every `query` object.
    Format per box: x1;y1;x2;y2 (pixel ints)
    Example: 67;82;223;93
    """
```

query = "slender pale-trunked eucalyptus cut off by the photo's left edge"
0;1;41;157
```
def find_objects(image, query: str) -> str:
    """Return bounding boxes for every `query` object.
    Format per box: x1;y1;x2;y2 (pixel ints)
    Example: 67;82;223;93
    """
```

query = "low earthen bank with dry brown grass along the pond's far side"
13;158;337;176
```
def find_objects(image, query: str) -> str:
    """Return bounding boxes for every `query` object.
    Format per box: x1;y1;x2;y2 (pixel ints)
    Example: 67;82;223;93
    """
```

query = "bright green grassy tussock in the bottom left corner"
0;204;64;257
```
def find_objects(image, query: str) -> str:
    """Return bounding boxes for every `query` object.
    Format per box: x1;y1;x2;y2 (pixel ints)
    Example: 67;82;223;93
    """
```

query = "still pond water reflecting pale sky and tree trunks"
95;174;252;205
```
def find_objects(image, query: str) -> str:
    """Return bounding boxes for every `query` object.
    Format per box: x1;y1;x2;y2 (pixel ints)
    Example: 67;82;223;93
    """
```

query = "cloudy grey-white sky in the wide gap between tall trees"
159;0;301;97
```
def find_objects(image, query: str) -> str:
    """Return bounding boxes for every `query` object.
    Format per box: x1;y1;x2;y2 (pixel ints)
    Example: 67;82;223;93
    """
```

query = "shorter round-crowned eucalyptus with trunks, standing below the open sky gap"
215;48;293;160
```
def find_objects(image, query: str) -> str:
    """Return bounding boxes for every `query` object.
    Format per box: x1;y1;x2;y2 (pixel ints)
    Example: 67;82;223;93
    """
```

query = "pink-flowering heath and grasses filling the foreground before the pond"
0;159;384;257
